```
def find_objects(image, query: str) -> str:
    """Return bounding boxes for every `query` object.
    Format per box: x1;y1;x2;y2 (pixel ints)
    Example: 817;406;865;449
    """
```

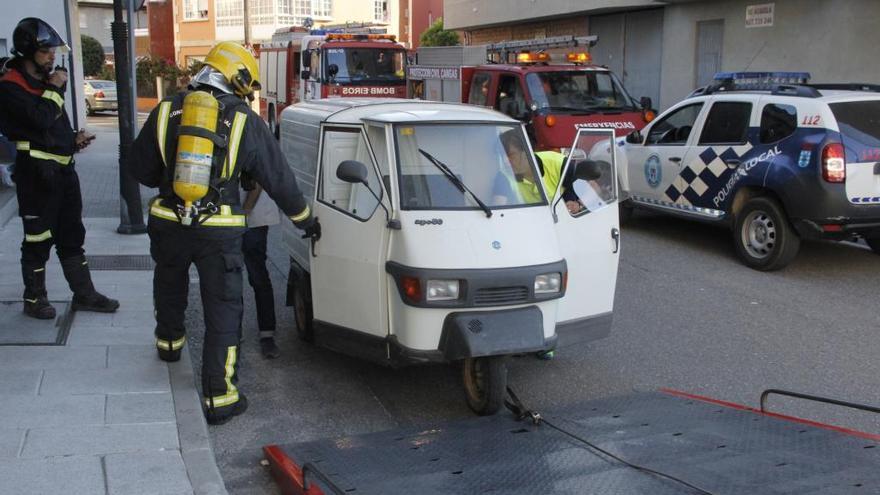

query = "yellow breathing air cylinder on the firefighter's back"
174;91;220;225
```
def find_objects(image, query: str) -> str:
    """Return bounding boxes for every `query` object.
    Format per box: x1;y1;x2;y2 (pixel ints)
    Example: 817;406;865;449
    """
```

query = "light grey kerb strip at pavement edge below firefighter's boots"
168;346;227;495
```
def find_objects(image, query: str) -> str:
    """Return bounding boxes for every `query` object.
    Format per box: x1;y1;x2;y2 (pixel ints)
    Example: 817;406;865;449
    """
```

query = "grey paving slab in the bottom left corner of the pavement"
0;456;106;495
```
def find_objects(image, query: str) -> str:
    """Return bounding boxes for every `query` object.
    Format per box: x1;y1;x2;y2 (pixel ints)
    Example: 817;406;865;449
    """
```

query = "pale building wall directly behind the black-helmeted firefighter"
0;0;86;129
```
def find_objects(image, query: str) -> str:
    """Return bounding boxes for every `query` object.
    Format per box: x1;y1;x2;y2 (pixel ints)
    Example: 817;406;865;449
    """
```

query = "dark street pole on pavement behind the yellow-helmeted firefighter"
110;0;147;234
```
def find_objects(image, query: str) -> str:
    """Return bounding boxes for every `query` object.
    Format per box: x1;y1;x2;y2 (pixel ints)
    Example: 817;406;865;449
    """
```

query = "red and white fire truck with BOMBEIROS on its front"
259;24;406;137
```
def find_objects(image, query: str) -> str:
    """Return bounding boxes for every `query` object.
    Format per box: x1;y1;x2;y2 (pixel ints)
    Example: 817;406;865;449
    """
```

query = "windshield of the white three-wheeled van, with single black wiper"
394;123;547;210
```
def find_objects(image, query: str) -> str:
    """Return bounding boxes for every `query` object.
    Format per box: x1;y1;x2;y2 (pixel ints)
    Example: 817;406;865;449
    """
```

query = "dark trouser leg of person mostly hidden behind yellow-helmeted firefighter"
242;225;275;338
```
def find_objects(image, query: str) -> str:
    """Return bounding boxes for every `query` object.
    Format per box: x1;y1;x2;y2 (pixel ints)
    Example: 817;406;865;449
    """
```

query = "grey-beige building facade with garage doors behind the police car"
444;0;880;108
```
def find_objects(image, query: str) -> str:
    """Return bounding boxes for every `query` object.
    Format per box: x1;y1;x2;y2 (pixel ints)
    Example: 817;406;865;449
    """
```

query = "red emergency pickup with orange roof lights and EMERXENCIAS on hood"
407;36;655;151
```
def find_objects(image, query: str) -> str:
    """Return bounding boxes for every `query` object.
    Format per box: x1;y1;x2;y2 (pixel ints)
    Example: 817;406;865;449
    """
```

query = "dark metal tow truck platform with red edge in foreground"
264;389;880;495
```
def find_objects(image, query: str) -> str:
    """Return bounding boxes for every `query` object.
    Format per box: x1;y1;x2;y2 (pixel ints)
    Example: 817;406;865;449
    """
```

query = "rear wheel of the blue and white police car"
734;197;801;271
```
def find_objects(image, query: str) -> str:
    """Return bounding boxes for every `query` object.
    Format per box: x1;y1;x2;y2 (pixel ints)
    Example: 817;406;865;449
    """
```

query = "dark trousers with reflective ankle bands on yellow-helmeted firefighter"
148;224;243;409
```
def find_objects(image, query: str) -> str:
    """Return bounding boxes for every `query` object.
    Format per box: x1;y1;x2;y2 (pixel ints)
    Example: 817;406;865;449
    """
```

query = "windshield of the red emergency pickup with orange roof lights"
526;70;639;113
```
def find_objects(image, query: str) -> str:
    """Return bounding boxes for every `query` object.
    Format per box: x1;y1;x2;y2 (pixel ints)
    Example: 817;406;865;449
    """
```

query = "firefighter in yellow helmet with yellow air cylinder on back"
130;42;320;424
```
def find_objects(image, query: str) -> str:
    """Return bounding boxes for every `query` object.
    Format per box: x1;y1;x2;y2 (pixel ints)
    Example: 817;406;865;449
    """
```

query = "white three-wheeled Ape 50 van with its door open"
281;98;620;414
